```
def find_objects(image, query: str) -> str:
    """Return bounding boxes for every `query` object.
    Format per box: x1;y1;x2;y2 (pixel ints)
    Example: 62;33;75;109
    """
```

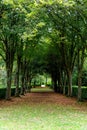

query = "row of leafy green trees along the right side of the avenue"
43;0;87;100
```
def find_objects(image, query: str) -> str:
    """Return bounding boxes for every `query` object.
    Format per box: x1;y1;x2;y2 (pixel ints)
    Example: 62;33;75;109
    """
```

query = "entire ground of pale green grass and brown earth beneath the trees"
0;88;87;130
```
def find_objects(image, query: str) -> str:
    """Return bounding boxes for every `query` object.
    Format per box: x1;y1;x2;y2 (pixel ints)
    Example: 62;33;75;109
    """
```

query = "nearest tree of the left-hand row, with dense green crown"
0;2;24;100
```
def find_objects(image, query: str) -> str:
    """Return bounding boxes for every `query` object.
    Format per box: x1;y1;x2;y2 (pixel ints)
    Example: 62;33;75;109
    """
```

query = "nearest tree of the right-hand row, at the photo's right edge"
75;0;87;101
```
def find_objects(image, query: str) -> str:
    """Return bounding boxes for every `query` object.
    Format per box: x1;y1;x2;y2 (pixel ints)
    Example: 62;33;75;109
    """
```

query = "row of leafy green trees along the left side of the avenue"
0;0;38;99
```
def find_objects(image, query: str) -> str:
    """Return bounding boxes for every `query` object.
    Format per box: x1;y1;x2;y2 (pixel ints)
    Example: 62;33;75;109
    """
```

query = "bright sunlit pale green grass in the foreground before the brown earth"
0;104;87;130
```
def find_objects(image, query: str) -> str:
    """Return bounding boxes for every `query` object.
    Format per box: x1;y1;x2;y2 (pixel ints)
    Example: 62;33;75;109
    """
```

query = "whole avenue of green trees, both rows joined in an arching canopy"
0;0;87;101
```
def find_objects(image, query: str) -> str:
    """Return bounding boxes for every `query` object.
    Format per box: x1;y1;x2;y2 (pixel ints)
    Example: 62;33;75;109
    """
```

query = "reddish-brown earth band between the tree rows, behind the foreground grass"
0;92;87;111
